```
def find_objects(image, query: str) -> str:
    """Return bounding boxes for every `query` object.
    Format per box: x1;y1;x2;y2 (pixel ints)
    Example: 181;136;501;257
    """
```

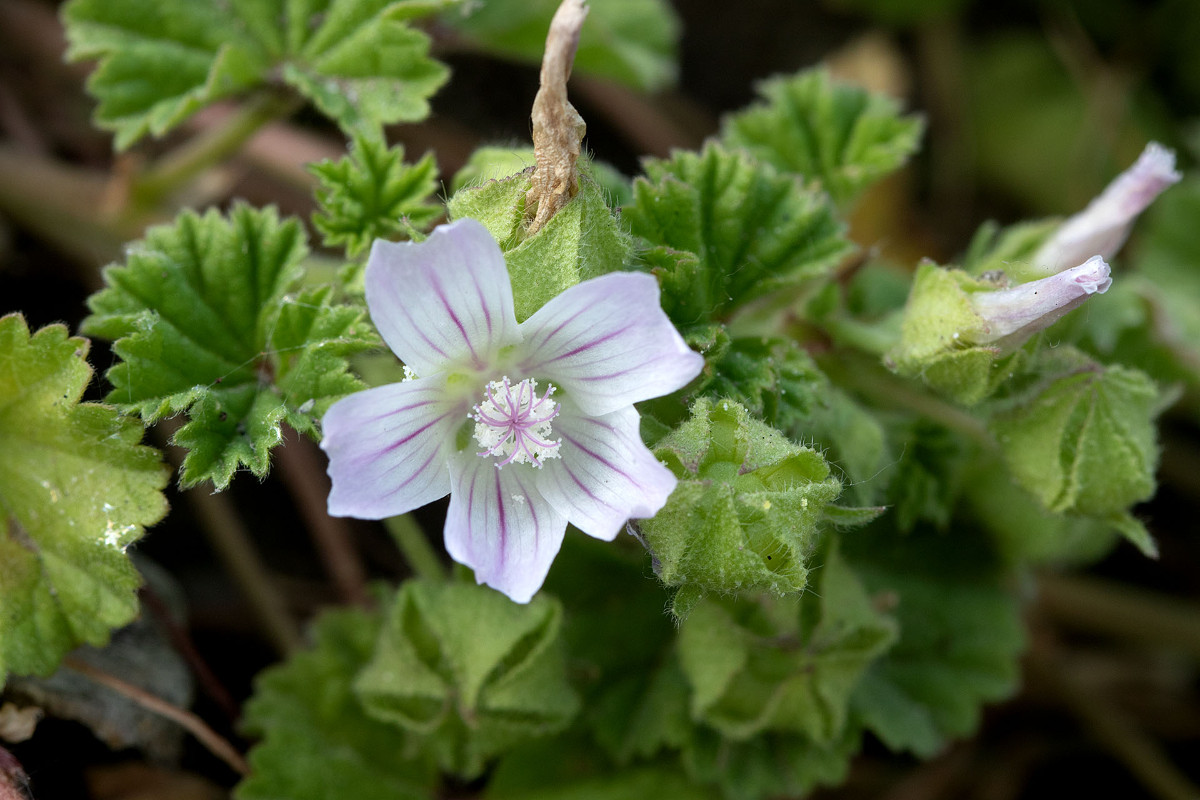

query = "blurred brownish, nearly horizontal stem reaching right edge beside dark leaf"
1038;572;1200;662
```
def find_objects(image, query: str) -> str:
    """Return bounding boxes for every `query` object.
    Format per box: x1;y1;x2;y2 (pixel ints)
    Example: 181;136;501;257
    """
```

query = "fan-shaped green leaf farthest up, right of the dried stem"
721;68;924;204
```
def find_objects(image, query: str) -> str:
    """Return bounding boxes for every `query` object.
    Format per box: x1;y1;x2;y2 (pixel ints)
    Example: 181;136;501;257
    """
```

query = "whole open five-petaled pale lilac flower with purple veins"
322;219;703;602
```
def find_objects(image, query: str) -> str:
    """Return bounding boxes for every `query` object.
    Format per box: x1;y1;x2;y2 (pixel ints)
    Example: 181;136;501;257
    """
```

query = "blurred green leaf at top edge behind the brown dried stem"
442;0;679;91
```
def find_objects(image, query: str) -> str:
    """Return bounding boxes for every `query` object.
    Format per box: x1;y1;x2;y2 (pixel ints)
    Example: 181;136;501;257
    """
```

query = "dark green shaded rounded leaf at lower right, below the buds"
842;525;1025;758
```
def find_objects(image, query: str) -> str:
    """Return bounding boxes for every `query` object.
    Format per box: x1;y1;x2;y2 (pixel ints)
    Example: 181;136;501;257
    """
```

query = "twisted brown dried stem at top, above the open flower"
526;0;588;235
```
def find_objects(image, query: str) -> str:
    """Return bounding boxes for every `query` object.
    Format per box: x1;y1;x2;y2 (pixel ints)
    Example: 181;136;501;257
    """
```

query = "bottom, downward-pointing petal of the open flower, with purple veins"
445;450;566;603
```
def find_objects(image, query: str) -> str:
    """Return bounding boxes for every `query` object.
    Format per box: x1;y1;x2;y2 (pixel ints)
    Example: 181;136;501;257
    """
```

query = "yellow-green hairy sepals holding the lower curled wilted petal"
886;261;1022;405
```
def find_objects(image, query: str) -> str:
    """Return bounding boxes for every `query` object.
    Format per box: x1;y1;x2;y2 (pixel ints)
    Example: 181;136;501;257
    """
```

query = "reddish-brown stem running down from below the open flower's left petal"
277;428;371;607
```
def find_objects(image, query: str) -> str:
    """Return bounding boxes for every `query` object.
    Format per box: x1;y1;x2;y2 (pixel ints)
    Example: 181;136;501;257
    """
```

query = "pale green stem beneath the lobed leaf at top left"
131;94;300;206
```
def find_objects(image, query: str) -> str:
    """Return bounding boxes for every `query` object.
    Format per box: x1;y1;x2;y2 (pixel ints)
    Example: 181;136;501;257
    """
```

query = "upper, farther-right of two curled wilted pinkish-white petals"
1033;142;1180;275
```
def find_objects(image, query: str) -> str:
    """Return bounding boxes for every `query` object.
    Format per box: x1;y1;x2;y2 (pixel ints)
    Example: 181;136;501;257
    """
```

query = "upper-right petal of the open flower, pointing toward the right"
520;272;704;415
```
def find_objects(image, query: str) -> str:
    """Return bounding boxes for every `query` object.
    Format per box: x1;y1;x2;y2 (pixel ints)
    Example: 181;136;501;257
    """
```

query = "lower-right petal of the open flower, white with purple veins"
535;398;677;541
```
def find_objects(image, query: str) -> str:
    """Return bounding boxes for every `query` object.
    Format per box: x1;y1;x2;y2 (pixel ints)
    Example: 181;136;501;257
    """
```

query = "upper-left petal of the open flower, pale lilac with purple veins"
365;219;521;375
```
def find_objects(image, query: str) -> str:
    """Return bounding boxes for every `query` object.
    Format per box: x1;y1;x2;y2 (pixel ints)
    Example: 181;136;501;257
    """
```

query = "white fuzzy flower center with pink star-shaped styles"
469;377;562;467
